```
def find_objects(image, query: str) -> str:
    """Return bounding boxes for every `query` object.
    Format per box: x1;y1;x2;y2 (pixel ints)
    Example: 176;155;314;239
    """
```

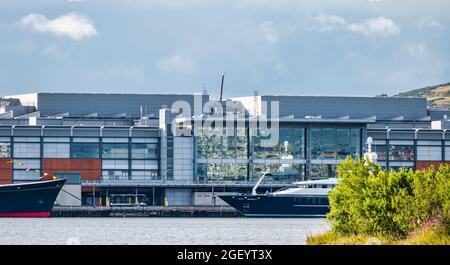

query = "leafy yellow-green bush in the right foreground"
327;157;450;238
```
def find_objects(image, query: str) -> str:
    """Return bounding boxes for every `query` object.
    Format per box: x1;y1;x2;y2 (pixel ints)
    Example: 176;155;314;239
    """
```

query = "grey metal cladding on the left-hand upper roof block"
37;93;209;117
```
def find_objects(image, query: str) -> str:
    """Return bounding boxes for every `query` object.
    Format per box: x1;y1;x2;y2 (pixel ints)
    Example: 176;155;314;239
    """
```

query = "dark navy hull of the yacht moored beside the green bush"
219;195;329;217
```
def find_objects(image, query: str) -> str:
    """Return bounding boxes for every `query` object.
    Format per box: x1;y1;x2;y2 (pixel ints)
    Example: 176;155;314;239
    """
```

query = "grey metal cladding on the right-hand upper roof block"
261;96;427;120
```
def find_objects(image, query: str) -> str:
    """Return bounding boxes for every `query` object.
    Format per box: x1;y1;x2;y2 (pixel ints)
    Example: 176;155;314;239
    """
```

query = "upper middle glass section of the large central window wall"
252;127;305;159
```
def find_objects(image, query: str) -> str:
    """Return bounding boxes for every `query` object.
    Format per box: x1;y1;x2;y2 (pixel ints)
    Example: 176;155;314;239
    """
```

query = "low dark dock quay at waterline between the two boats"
51;206;242;217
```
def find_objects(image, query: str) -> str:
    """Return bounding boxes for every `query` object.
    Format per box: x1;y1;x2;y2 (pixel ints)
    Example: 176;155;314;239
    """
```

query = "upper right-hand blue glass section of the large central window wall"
311;128;361;160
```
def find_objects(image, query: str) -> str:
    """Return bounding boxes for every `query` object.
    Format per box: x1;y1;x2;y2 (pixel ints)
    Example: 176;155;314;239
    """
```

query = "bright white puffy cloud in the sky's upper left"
18;13;97;40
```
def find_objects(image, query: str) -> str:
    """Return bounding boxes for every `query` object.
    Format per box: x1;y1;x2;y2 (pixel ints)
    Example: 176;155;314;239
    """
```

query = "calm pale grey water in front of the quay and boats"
0;218;329;245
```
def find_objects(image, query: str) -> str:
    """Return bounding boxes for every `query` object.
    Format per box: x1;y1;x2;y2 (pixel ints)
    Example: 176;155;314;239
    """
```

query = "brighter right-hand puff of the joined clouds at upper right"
347;17;400;36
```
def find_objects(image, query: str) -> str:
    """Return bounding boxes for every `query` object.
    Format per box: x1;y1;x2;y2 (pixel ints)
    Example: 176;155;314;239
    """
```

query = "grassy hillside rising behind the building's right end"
394;83;450;110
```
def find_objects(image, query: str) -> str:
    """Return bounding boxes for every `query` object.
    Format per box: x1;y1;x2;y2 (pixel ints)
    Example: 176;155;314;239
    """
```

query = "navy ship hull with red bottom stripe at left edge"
0;179;66;217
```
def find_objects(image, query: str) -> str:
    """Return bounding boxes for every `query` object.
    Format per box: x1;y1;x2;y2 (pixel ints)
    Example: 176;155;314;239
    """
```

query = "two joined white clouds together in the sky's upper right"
312;14;400;36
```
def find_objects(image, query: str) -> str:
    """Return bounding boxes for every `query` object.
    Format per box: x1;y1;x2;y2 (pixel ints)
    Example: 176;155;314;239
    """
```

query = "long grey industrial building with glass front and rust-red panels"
0;92;450;206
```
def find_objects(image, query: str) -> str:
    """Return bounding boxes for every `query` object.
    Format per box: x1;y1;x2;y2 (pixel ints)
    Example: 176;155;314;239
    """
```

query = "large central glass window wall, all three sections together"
196;124;362;182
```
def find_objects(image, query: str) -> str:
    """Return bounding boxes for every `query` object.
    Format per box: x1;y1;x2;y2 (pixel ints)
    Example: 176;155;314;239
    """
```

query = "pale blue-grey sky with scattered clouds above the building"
0;0;450;97
